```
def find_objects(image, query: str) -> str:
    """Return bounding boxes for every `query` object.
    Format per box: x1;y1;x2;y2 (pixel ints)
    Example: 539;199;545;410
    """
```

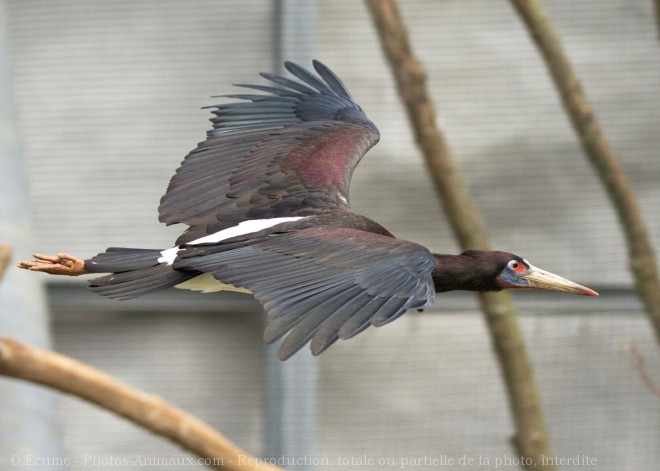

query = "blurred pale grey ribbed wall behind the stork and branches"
5;0;660;470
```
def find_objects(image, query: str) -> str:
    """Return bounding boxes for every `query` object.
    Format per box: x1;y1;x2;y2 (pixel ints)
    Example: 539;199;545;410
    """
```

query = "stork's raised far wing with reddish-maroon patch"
158;61;379;244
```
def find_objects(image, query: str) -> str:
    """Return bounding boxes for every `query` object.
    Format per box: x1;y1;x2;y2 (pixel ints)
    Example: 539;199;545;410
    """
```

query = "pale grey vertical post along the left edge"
0;0;62;470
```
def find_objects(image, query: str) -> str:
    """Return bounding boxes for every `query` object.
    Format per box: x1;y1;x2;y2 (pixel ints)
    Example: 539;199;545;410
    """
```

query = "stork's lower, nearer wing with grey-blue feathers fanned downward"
174;227;435;360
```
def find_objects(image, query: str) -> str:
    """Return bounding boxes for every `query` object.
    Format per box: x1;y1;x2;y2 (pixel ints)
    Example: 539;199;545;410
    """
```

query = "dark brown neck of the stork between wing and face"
433;254;501;293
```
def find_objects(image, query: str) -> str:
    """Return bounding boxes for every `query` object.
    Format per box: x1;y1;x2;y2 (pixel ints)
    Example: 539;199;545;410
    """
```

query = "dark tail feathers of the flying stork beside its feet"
85;247;199;299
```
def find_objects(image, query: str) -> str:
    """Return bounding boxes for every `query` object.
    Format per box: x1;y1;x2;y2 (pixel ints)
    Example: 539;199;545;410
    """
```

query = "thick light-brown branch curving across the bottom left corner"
0;337;282;471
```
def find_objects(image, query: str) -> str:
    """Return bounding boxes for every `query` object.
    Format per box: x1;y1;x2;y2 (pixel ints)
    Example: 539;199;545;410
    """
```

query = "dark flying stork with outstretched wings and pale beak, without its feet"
80;61;595;359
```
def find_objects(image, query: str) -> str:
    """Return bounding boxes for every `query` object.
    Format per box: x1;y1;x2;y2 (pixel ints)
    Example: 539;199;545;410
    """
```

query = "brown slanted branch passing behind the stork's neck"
366;0;554;471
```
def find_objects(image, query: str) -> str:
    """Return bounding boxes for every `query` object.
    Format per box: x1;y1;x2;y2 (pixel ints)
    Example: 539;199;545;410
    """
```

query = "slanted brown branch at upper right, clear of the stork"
511;0;660;342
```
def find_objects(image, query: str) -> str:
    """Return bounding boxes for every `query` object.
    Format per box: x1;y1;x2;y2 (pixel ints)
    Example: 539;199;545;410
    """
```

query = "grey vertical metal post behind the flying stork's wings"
264;0;318;471
